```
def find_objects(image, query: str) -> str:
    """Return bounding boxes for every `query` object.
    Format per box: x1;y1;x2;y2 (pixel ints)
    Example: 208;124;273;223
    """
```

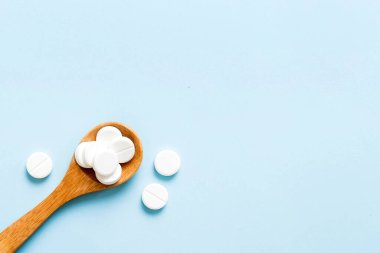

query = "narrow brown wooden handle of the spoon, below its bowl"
0;185;73;253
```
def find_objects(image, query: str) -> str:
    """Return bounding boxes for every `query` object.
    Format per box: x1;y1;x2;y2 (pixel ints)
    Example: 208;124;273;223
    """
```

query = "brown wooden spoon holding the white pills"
0;122;143;253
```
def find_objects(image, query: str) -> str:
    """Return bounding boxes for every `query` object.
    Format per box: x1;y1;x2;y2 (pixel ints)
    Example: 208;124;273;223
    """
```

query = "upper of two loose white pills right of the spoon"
154;150;181;176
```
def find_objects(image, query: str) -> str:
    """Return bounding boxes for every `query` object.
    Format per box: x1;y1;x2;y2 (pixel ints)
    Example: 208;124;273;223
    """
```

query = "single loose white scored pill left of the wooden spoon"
26;152;53;179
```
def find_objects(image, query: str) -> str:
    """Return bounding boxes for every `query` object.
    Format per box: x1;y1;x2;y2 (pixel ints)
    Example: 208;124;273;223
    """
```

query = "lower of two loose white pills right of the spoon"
142;184;169;210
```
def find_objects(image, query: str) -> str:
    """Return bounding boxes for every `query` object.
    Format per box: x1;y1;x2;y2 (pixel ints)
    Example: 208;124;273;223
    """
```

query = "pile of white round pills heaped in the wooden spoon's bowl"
75;126;135;185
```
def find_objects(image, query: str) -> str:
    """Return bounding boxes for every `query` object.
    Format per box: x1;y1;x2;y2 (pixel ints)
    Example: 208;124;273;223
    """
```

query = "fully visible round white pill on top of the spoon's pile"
94;151;118;177
